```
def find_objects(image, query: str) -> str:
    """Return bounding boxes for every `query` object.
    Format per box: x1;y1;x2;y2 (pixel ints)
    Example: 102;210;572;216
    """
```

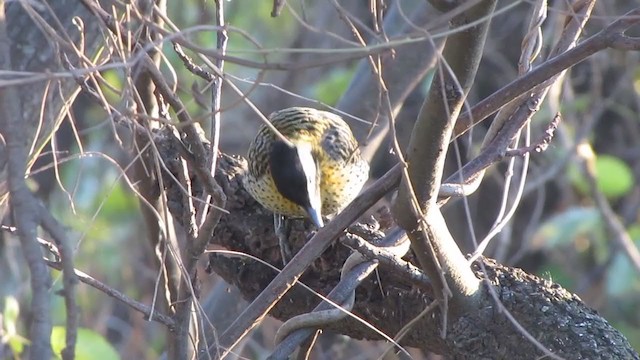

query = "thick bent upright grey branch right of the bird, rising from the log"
394;1;495;311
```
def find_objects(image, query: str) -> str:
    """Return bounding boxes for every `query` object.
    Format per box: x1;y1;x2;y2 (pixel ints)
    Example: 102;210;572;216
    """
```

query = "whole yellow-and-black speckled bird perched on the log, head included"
244;107;369;226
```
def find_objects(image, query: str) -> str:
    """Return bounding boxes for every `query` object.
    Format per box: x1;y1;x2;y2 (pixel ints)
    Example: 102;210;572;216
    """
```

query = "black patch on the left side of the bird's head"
269;140;311;208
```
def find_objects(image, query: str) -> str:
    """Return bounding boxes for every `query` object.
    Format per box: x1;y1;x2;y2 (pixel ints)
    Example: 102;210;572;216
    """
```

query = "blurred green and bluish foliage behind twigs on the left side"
42;148;145;359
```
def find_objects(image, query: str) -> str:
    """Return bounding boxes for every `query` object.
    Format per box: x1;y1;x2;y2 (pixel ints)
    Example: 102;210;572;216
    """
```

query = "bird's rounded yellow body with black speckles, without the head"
245;107;369;217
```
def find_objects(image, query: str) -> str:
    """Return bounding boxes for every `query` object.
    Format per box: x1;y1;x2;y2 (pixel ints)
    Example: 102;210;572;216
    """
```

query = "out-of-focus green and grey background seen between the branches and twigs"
0;0;640;359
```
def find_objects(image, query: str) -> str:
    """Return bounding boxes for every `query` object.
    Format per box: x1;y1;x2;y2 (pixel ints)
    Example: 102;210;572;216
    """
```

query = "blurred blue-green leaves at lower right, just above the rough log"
532;207;640;349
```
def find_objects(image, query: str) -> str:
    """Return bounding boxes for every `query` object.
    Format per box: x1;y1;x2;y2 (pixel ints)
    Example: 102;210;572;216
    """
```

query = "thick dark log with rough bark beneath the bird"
158;131;639;359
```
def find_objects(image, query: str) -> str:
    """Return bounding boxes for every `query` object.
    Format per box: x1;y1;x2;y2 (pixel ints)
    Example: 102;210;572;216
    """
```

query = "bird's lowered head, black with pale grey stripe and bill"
269;140;324;228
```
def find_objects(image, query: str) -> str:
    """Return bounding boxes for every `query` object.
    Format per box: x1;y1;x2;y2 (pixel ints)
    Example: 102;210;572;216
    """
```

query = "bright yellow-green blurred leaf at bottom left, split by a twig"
51;326;120;360
